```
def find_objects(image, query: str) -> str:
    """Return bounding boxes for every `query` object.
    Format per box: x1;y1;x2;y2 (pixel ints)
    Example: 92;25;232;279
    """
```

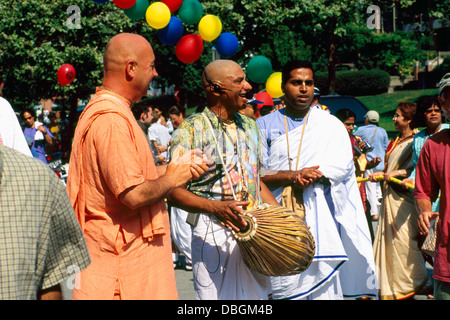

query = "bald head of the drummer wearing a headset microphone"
202;60;252;112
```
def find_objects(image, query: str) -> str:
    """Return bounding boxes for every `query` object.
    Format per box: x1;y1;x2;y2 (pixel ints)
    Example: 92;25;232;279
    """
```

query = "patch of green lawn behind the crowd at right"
357;89;438;138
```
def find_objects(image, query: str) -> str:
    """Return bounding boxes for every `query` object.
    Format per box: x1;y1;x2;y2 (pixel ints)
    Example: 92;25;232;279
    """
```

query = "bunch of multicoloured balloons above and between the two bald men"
93;0;239;63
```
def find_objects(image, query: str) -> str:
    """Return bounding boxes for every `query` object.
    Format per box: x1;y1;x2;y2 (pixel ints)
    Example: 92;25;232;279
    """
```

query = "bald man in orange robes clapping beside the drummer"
67;33;206;300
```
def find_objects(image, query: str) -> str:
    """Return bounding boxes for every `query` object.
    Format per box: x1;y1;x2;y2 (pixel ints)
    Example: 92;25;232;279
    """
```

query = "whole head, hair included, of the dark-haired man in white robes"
281;60;314;112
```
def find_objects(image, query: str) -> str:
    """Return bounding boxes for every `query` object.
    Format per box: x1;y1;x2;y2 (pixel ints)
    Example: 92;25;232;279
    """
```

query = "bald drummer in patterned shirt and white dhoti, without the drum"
169;60;278;300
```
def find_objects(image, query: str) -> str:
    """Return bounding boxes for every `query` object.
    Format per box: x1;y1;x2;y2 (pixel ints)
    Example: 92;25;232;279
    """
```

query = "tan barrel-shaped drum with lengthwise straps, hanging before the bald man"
233;204;315;276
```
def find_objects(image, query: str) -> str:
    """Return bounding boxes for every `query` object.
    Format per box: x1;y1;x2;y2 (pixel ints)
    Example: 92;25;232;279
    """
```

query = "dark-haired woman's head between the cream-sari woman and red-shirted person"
411;96;443;129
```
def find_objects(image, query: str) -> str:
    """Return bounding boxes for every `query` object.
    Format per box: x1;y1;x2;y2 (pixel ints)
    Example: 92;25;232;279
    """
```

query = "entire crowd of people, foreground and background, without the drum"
0;33;450;300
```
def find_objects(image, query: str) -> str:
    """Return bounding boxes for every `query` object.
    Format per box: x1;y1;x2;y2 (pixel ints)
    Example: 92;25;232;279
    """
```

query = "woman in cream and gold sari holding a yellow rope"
370;102;428;300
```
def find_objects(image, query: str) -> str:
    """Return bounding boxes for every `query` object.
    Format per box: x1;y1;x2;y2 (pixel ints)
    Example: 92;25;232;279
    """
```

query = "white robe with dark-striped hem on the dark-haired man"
260;109;378;299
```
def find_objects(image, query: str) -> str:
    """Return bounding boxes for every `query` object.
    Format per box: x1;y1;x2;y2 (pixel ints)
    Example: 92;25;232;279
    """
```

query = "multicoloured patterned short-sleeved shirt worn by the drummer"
171;108;262;208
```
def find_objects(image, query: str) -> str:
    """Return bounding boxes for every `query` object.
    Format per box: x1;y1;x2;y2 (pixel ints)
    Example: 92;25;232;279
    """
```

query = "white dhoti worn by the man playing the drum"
192;214;269;300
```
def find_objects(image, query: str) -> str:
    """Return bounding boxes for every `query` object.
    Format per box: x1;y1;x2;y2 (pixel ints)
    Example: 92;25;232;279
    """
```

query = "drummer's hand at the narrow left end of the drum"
213;200;250;232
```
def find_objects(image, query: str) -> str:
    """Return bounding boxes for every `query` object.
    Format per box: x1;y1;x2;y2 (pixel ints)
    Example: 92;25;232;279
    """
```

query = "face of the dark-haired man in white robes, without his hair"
282;68;314;115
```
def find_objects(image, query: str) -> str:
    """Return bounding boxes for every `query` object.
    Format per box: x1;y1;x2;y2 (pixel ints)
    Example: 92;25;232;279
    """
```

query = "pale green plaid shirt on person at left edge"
0;145;90;300
